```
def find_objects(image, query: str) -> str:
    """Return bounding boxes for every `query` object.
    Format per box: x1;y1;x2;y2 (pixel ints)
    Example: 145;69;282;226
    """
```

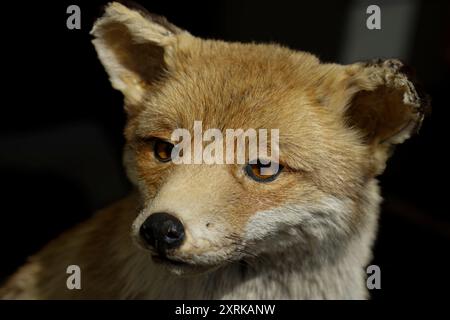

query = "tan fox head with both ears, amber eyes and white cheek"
92;3;426;273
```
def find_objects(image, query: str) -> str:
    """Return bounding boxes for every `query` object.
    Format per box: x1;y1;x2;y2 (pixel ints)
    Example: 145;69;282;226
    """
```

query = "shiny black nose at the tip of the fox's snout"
140;212;184;254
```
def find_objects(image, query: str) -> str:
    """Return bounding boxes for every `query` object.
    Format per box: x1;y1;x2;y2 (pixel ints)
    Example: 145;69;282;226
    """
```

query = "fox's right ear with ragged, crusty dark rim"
328;59;430;173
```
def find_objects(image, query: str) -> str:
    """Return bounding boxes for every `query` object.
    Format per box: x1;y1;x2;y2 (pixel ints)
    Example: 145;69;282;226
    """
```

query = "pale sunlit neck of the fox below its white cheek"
218;226;370;299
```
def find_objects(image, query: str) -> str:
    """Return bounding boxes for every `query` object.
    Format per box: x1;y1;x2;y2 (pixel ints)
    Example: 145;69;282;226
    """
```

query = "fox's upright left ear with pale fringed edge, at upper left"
91;2;187;104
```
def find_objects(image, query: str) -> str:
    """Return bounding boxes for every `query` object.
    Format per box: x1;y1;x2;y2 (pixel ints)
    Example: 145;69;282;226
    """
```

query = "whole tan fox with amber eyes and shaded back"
0;2;429;300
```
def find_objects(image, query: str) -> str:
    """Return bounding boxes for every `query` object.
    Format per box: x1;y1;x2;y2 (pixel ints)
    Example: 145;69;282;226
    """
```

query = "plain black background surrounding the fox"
0;0;450;299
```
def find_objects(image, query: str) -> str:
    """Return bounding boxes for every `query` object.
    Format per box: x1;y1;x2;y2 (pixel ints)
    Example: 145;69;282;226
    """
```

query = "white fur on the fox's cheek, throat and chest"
122;180;381;299
